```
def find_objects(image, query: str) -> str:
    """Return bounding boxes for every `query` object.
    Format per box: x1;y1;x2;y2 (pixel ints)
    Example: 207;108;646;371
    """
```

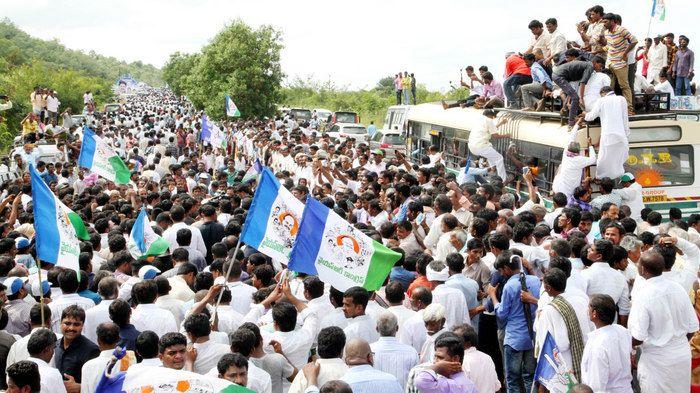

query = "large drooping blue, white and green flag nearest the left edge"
29;164;90;272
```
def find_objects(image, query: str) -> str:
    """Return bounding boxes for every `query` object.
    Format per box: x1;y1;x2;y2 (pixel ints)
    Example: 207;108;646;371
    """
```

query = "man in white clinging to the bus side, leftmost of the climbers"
468;109;509;181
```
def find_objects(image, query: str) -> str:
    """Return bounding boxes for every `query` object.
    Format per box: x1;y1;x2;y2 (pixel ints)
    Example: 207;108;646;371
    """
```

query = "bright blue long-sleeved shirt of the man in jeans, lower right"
495;274;540;351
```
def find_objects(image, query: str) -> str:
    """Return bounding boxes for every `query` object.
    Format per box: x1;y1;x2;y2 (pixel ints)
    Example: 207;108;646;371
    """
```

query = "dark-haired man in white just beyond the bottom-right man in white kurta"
581;240;630;325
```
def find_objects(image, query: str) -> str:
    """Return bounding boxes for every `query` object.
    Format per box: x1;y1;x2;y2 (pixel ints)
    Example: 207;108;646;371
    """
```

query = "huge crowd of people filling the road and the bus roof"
0;6;700;393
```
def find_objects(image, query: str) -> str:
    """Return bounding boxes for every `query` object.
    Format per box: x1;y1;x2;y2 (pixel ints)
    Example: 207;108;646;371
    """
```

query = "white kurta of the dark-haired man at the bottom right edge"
581;324;632;393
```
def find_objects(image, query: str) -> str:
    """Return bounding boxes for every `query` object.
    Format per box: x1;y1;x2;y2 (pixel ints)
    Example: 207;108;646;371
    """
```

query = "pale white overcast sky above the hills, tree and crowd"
0;0;700;90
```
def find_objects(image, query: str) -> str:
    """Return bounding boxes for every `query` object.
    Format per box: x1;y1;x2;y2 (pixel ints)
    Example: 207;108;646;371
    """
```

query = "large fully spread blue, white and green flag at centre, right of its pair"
289;197;401;291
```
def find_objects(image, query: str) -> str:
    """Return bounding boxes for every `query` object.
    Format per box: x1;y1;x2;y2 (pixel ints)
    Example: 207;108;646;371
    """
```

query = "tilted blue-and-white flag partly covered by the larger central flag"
241;168;304;265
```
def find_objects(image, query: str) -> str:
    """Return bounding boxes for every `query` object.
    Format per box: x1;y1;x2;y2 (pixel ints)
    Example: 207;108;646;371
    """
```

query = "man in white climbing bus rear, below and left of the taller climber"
552;121;596;198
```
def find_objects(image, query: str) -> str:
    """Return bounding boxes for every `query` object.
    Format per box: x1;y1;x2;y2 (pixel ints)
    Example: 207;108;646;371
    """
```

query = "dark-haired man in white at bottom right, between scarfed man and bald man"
581;294;632;393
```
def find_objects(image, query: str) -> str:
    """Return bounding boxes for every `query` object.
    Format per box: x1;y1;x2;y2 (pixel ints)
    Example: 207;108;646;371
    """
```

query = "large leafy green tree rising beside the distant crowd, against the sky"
163;19;283;118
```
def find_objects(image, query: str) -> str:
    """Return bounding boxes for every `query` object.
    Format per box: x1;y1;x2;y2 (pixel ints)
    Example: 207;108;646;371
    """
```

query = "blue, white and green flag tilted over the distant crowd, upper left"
78;126;131;184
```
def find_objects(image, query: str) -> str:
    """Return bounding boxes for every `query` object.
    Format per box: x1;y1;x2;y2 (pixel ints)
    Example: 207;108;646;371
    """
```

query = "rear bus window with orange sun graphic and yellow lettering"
625;145;695;187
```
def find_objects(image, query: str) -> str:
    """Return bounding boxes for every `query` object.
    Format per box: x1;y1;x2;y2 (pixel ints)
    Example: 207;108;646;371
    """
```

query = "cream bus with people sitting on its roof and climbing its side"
406;103;700;219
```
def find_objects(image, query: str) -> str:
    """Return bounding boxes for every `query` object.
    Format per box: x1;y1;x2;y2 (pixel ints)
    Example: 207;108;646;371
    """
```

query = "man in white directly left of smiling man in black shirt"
27;329;66;393
